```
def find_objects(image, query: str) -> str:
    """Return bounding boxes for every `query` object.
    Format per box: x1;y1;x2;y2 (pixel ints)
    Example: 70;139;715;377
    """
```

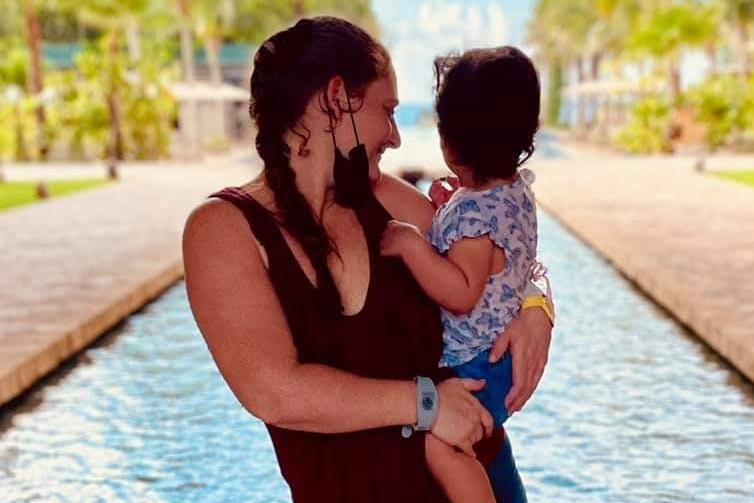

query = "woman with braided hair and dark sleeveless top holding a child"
184;18;551;503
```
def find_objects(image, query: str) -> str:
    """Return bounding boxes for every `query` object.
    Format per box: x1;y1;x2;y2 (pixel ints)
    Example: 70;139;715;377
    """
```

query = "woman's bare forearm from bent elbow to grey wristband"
262;364;416;433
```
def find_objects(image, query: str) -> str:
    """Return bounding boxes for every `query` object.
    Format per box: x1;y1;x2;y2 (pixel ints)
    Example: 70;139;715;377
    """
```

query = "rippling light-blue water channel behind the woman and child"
0;200;754;503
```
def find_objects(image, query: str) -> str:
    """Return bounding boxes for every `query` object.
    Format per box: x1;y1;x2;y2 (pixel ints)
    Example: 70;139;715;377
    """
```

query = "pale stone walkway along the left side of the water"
0;154;256;405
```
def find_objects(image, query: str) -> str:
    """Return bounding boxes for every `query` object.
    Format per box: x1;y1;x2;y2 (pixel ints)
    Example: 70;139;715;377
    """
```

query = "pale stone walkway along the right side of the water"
532;146;754;381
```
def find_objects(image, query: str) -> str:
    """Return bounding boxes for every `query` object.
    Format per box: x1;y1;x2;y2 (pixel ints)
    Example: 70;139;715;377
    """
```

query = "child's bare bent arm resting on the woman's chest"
380;220;495;313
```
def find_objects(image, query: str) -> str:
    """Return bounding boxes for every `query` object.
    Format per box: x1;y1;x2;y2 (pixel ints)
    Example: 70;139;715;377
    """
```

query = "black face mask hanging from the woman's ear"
330;91;372;208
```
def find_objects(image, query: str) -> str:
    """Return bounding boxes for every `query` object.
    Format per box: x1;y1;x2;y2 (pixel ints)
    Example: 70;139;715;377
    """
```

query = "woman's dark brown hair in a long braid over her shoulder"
249;16;390;314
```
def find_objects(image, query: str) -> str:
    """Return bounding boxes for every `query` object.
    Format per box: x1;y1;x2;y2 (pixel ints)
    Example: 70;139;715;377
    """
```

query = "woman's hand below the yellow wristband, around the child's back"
490;308;552;414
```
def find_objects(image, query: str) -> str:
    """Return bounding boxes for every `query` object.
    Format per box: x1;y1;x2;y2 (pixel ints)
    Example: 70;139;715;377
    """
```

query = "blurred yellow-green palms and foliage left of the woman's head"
0;0;377;162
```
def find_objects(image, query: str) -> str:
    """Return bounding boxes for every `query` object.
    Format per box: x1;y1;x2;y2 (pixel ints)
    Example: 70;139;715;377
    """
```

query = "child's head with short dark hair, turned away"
435;46;540;184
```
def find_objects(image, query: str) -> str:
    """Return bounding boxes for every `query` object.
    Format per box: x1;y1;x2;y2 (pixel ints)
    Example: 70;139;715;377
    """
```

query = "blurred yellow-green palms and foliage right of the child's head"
528;0;754;151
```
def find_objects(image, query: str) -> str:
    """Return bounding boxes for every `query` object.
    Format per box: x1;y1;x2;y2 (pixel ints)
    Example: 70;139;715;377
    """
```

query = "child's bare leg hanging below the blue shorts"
424;433;495;503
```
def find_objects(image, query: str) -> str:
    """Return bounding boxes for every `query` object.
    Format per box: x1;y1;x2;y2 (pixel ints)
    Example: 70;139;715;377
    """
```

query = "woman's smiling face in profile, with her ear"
338;67;401;180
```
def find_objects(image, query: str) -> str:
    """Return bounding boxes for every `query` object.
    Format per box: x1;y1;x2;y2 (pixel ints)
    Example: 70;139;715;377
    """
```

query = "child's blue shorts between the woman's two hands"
452;349;513;428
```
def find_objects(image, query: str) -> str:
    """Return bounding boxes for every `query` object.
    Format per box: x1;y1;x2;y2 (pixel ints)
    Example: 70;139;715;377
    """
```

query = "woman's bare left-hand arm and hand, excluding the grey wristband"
183;200;483;443
